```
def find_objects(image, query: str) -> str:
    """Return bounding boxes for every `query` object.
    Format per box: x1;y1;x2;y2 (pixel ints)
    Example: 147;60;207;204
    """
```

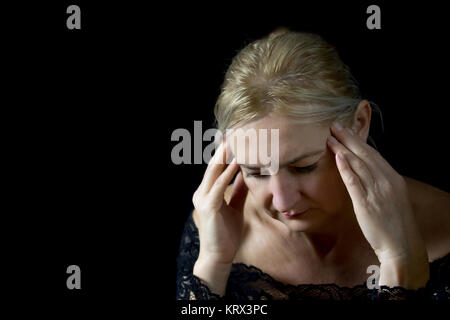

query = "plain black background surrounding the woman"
2;1;449;314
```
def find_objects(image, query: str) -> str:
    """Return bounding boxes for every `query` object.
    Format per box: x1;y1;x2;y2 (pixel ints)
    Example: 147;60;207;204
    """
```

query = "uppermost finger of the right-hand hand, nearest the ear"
331;122;393;175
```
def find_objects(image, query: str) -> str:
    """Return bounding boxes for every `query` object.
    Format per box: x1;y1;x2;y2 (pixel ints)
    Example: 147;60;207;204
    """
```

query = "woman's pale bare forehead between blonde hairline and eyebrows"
227;115;329;163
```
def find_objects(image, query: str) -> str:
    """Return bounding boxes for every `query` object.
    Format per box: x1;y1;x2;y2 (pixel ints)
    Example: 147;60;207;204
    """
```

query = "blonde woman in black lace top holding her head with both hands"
177;28;450;300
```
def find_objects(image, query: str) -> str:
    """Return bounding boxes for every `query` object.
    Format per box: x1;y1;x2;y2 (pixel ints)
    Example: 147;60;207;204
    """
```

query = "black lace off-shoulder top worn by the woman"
176;214;450;301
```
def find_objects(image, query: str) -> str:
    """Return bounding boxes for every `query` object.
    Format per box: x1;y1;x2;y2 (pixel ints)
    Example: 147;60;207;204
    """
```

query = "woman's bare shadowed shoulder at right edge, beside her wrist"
404;177;450;261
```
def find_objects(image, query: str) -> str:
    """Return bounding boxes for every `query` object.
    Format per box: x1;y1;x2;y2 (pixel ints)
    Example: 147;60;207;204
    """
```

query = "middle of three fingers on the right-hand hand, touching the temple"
327;136;375;191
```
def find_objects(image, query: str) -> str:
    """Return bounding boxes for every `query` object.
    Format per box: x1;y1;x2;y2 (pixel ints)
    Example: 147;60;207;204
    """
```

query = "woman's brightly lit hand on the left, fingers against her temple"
192;143;248;265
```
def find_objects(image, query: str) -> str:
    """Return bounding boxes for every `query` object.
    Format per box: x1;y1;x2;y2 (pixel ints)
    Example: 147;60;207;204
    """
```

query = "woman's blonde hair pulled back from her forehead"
214;27;380;132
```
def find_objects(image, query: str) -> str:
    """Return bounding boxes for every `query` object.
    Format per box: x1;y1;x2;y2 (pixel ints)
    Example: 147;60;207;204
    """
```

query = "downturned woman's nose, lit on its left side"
269;172;302;212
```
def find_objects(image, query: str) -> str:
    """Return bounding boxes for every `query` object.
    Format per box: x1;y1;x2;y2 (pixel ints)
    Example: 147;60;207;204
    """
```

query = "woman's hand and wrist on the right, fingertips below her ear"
327;121;429;288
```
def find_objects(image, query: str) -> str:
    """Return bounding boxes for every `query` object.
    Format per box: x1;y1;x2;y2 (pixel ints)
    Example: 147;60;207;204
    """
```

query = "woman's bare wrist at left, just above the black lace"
193;259;231;296
